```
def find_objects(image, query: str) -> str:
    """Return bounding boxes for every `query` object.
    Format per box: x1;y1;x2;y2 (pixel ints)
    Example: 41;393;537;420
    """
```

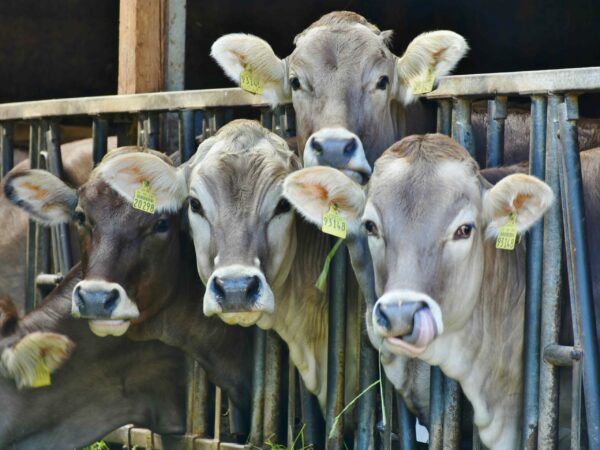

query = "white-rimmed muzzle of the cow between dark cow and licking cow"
203;265;275;326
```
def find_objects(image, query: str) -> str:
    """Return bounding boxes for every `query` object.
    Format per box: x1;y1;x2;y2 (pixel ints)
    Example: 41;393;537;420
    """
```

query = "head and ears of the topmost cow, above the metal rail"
211;11;468;182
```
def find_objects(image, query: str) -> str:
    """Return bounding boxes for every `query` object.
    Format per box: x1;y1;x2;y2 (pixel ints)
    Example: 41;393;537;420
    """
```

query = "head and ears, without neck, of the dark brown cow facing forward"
5;147;186;336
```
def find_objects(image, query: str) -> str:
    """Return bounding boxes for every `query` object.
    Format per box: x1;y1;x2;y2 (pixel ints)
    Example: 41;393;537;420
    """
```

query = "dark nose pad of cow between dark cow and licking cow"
211;275;261;313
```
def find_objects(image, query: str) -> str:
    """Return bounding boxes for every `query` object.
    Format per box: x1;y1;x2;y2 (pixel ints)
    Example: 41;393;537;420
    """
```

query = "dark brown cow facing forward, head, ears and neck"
4;146;253;426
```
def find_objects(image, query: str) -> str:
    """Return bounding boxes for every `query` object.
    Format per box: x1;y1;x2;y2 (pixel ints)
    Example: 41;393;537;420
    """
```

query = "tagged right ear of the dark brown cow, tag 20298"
95;152;187;213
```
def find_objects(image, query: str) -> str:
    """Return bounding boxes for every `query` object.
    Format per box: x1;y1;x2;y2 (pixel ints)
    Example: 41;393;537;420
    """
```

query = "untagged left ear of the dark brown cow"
4;169;78;225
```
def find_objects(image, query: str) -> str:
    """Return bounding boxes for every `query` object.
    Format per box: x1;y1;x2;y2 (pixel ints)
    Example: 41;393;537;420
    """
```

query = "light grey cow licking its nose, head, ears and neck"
284;134;600;449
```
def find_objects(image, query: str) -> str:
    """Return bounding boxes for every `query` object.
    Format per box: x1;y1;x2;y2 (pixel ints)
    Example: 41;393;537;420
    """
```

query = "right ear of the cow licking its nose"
483;174;554;238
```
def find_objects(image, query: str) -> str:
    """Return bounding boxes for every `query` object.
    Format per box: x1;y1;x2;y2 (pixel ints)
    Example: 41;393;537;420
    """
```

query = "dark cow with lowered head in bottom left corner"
0;274;186;450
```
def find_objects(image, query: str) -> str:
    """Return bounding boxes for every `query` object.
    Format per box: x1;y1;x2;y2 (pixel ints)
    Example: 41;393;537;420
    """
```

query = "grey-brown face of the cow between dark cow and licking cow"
188;121;299;326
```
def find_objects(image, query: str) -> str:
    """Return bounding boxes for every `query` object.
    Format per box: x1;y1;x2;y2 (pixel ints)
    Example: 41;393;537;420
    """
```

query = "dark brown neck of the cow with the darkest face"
130;236;253;410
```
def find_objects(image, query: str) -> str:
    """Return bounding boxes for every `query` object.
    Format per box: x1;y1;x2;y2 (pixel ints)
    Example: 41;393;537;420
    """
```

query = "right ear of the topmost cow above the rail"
397;30;469;105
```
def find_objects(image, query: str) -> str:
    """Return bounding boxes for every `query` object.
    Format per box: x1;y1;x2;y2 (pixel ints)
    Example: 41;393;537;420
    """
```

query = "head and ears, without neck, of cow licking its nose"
285;135;553;360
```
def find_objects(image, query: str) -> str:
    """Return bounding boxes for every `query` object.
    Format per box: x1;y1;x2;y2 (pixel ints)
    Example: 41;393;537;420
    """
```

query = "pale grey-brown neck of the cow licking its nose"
429;241;526;449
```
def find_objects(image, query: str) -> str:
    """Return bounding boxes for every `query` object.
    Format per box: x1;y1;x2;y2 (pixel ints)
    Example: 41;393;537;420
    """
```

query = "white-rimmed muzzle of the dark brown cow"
71;280;140;336
